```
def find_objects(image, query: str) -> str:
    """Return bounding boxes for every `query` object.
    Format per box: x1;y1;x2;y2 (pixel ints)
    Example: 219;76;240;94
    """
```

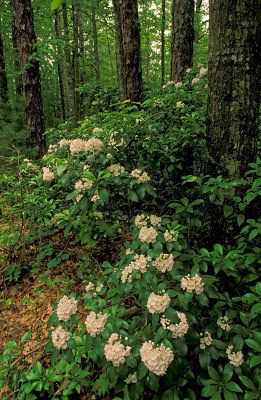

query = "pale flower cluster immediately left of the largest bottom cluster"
104;333;131;367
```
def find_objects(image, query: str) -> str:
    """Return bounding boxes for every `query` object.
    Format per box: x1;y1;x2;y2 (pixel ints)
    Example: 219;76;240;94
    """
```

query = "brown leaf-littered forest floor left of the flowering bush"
0;197;114;400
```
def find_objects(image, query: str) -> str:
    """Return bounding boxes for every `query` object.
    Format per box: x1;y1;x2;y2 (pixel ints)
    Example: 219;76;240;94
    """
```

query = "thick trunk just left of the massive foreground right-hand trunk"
170;0;194;82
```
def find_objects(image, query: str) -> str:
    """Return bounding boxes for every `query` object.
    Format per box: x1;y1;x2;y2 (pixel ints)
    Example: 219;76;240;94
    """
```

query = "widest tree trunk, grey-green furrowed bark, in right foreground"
207;0;261;177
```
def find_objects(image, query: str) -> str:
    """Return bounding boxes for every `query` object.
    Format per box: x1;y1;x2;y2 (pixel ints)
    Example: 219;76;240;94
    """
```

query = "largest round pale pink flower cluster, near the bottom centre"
140;341;174;376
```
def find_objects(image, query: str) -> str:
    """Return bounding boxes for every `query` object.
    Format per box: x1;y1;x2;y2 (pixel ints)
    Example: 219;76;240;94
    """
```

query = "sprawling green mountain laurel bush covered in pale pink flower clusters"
0;68;261;400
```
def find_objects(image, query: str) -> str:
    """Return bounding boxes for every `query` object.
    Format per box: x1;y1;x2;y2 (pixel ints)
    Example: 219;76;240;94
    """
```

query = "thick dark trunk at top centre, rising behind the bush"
111;0;142;101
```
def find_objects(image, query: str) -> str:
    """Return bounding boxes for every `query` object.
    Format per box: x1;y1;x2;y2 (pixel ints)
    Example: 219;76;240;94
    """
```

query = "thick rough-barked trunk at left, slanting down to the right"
11;0;46;157
